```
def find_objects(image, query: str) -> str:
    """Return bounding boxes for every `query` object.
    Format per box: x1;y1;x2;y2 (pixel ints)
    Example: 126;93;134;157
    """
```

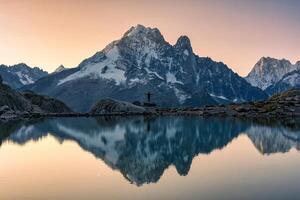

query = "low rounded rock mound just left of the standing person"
90;99;146;114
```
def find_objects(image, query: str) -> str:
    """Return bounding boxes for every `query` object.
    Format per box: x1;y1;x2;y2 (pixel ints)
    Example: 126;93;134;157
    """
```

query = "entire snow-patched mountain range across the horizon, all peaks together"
0;25;300;112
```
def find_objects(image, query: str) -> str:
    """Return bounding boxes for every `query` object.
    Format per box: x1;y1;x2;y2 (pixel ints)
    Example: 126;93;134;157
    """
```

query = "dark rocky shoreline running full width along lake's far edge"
0;90;300;121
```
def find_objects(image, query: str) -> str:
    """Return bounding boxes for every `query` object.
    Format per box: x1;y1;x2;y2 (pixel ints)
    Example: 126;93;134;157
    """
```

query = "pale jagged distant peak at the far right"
245;57;300;90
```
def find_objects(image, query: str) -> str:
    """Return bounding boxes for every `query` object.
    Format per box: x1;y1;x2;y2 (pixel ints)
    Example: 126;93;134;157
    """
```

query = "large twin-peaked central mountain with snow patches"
24;25;266;111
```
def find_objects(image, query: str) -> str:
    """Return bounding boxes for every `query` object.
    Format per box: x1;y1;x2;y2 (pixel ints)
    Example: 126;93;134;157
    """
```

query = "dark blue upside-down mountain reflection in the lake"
0;117;300;186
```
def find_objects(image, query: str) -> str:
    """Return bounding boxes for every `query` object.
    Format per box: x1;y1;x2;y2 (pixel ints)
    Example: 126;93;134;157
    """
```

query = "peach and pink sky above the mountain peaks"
0;0;300;76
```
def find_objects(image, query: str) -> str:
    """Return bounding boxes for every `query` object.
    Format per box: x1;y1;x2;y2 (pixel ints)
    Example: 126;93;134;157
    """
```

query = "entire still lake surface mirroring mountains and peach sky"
0;117;300;200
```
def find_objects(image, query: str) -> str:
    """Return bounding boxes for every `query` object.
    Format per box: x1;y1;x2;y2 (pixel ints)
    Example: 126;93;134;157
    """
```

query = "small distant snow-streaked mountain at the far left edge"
0;63;48;89
